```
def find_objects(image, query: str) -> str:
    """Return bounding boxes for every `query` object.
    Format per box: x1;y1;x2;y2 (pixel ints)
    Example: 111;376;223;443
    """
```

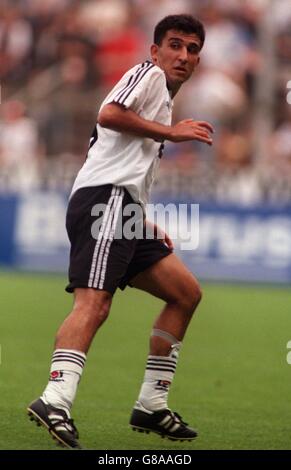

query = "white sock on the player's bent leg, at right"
135;349;178;411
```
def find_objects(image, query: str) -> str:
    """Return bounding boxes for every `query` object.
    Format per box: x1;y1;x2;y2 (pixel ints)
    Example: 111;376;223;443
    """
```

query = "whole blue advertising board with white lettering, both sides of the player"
0;192;291;283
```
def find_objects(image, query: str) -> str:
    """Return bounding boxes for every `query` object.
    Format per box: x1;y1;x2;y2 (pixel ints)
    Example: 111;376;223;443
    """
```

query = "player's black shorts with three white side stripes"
66;185;172;295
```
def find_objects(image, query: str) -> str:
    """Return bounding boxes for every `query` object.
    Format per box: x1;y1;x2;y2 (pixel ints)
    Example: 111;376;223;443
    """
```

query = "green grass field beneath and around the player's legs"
0;273;291;450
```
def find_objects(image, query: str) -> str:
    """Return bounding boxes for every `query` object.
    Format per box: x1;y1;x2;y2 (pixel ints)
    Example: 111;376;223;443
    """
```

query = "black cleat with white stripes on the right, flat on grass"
129;408;198;441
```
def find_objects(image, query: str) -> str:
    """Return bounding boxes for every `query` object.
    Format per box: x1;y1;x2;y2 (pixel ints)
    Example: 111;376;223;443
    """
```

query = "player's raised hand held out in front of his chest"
169;119;214;145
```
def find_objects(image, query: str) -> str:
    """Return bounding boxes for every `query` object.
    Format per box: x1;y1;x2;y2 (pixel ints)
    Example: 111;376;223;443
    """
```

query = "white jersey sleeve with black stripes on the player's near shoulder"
106;62;166;112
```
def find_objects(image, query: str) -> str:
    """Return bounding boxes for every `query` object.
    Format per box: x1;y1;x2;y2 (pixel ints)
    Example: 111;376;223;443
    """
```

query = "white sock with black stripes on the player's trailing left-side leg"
41;349;86;417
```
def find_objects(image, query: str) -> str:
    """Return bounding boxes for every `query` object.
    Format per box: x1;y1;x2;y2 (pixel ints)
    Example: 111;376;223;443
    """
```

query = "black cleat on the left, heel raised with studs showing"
27;398;81;449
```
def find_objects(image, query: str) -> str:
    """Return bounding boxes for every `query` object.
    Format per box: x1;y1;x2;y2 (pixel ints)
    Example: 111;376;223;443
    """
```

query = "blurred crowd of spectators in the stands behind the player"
0;0;291;205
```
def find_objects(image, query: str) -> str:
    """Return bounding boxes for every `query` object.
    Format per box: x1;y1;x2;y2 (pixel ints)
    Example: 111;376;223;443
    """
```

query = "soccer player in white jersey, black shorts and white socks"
28;15;213;448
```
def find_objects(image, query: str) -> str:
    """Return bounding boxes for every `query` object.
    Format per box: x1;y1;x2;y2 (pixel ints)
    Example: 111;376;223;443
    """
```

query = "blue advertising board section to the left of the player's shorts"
0;192;69;272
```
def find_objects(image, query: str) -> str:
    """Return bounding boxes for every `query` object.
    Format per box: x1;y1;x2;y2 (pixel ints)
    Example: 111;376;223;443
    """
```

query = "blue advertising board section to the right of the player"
179;205;291;283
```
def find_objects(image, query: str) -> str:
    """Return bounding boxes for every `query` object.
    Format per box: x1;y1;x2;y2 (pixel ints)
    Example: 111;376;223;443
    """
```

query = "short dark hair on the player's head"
154;15;205;49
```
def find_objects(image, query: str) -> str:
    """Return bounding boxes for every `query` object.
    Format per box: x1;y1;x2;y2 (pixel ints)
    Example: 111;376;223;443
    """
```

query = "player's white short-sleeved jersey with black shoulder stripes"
71;61;172;208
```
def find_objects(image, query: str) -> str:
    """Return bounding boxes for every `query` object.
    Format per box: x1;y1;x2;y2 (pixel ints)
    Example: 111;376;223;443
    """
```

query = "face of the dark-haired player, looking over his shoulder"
151;29;201;91
